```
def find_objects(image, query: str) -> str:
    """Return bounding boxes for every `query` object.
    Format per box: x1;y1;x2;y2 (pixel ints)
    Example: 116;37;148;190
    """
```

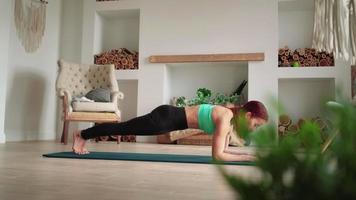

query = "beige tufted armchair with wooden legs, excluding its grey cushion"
56;60;124;144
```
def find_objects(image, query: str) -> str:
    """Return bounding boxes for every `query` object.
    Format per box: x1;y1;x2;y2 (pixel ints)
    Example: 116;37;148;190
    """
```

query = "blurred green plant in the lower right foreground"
217;98;356;200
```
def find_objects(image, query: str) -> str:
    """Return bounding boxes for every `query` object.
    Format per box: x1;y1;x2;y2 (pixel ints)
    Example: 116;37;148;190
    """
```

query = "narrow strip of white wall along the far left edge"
0;0;12;143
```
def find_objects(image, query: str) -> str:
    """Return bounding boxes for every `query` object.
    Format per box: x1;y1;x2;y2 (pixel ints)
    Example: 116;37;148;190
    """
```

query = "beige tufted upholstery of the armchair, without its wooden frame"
56;60;123;114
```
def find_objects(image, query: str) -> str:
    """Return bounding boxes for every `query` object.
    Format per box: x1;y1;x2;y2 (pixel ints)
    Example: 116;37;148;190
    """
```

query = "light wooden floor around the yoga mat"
0;142;257;200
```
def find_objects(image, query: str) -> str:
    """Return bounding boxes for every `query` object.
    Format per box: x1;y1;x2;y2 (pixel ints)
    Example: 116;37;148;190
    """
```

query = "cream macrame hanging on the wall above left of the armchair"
14;0;48;53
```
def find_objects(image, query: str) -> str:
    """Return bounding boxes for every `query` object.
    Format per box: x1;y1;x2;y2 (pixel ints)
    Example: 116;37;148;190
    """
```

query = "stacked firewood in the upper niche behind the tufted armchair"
94;48;138;69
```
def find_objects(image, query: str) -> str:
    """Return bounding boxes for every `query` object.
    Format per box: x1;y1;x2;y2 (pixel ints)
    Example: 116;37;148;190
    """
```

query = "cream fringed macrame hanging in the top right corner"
312;0;356;65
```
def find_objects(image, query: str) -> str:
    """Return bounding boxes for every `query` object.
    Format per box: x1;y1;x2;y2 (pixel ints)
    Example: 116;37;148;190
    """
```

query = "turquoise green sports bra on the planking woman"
198;104;215;135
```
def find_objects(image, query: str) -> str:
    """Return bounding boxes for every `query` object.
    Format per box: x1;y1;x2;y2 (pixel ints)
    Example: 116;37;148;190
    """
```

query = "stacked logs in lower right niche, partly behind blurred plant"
278;115;332;141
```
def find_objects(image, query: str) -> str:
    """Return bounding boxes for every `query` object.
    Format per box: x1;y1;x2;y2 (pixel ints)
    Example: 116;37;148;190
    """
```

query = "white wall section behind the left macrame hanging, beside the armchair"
5;1;61;141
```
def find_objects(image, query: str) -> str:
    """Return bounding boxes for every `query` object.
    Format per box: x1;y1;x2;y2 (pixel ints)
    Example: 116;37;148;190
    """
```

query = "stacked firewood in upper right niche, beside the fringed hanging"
278;47;335;67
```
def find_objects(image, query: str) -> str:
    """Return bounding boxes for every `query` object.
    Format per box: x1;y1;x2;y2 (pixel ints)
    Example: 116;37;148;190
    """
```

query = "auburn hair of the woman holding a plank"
229;101;268;121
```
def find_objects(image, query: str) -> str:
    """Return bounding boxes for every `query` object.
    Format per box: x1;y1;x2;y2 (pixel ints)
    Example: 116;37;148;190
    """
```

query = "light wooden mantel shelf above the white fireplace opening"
149;53;265;63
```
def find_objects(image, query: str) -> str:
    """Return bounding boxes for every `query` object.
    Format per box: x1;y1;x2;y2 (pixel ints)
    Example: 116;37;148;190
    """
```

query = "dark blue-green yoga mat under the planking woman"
43;151;254;165
